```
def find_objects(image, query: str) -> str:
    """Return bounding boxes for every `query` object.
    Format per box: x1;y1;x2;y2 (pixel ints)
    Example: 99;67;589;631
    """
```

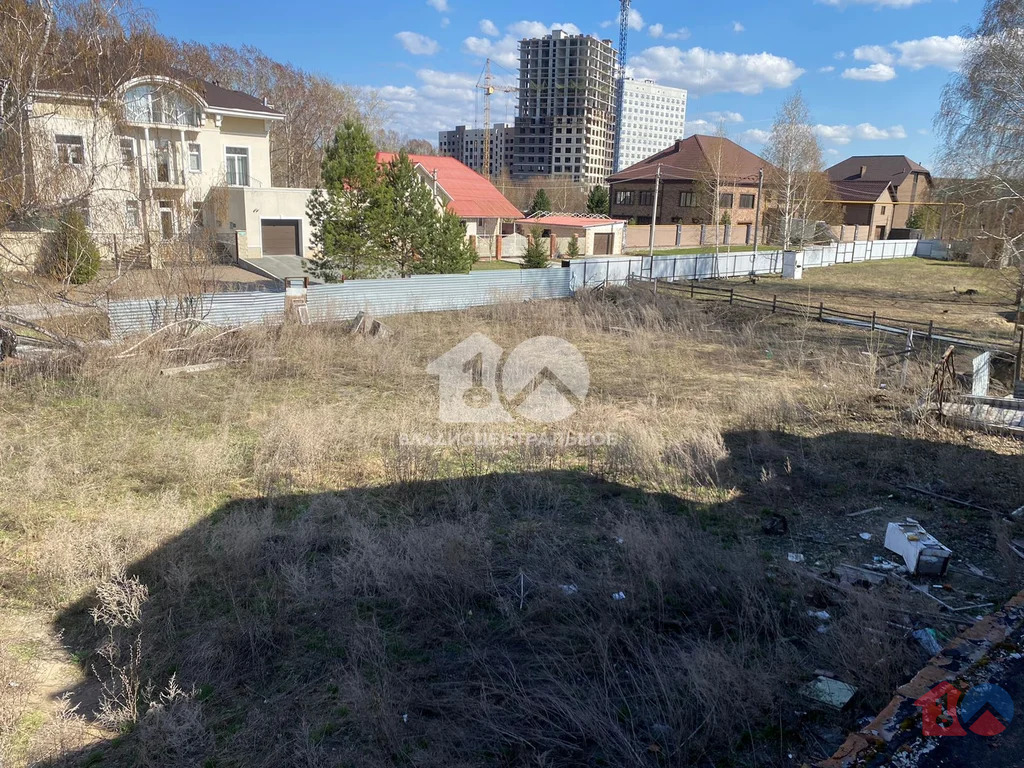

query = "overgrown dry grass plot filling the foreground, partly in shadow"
0;290;1024;768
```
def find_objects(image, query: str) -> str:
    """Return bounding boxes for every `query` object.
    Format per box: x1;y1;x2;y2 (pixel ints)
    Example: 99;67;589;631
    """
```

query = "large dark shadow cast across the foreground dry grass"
36;432;1021;768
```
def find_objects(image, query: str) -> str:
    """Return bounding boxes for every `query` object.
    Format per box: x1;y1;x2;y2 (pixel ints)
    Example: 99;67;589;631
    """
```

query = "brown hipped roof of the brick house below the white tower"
608;135;770;183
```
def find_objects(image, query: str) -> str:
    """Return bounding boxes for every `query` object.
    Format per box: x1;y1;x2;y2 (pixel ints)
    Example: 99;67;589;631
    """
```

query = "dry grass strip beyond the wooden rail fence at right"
708;258;1019;343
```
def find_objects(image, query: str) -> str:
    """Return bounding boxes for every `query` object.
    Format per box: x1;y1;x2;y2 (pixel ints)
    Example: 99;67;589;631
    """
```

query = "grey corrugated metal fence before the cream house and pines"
108;268;572;339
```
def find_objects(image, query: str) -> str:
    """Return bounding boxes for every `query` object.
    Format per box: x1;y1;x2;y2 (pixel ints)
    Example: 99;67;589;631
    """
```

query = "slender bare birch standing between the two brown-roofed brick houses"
764;92;833;248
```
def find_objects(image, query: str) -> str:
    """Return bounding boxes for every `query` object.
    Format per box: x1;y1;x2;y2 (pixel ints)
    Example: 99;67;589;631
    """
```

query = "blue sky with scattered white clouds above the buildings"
142;0;982;165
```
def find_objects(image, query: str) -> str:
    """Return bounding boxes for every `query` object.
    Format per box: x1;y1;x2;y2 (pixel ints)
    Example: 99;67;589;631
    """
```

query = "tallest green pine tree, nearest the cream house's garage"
306;120;381;283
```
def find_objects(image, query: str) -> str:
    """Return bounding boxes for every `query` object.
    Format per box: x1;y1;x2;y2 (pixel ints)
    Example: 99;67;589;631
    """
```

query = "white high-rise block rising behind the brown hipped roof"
615;78;686;173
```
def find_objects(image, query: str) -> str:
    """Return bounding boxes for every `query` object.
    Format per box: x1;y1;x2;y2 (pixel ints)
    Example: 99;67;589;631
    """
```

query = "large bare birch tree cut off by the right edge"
936;0;1024;304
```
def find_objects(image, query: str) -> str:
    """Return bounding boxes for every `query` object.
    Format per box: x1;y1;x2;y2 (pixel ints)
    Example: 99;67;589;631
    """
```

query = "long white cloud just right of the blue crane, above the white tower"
630;46;804;95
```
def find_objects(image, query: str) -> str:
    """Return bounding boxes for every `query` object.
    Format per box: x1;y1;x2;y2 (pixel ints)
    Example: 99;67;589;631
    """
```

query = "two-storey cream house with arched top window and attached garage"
24;73;310;268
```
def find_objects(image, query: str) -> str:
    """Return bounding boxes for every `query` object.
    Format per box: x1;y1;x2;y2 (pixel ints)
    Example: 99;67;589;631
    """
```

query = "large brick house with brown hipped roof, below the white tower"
608;135;769;237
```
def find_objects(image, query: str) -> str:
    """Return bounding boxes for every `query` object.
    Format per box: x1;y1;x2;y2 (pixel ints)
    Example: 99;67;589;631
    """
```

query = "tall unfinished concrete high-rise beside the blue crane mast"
512;30;616;185
